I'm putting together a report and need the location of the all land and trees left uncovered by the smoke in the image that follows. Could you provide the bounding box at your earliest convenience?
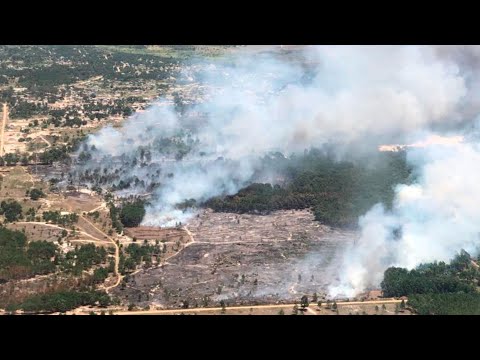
[0,46,474,315]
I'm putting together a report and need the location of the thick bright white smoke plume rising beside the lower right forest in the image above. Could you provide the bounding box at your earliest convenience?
[330,139,480,296]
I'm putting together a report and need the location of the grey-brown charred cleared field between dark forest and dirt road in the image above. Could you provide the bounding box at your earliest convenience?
[114,210,356,307]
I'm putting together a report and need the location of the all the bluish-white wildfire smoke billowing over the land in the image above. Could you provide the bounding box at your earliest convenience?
[73,46,480,295]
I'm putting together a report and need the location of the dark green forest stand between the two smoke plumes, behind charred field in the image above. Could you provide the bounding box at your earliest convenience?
[203,150,411,227]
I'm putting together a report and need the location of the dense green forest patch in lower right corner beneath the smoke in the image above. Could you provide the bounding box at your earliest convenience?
[381,251,480,315]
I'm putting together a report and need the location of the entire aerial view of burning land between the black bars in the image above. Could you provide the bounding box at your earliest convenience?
[0,45,480,315]
